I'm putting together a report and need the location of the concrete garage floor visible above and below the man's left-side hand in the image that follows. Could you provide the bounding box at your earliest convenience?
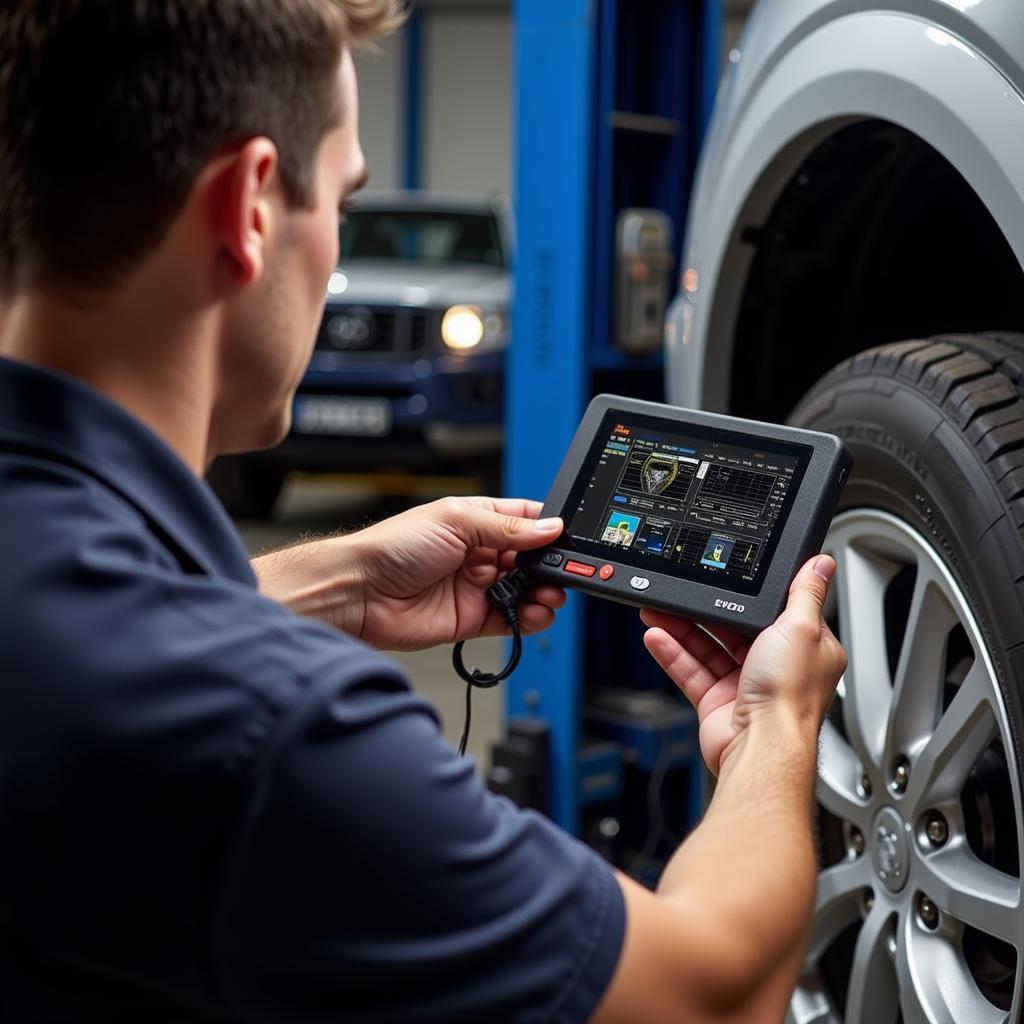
[238,474,504,769]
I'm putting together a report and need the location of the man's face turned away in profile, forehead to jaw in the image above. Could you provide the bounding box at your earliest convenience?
[216,49,366,451]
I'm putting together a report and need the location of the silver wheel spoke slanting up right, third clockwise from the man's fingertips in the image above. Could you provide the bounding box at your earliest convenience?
[905,662,998,812]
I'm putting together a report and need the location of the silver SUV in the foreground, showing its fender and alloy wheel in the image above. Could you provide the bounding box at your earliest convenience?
[668,0,1024,1024]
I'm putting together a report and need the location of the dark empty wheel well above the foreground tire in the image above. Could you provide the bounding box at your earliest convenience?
[729,121,1024,421]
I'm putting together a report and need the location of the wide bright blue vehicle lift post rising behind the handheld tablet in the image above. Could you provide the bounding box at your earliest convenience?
[505,0,722,847]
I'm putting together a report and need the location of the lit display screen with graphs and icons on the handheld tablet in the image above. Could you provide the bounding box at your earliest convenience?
[563,412,812,594]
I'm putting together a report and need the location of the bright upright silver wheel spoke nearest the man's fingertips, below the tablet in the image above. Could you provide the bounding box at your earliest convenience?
[836,544,896,767]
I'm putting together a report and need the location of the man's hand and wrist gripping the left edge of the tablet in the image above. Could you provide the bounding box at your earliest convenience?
[254,498,565,650]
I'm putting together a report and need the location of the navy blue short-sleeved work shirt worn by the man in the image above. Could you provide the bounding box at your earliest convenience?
[0,359,625,1024]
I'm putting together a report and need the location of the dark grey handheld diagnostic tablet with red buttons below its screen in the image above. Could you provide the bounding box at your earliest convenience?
[517,395,852,635]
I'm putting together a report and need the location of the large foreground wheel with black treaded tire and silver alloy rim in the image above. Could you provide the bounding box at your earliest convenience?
[788,335,1024,1024]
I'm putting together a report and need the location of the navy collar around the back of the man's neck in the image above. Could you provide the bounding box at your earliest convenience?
[0,356,256,586]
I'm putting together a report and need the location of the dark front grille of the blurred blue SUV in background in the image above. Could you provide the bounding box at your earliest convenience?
[316,306,440,358]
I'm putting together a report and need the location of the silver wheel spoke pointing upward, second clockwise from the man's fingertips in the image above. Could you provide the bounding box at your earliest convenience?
[885,564,957,766]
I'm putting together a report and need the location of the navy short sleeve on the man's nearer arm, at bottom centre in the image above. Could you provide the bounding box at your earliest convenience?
[216,658,625,1024]
